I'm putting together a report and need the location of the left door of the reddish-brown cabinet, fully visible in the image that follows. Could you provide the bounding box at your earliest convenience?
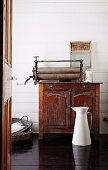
[43,91,70,129]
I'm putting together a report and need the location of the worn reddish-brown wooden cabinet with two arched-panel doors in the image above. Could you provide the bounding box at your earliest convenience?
[39,82,100,139]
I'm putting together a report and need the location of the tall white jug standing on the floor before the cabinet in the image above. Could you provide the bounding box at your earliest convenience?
[72,107,91,146]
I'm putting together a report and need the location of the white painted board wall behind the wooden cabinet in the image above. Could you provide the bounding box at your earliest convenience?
[12,0,108,133]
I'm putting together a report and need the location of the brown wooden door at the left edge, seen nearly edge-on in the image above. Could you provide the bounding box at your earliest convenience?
[0,0,12,170]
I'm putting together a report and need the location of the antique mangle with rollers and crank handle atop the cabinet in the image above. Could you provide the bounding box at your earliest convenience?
[25,56,83,84]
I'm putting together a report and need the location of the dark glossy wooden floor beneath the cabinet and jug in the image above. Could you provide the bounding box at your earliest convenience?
[11,134,108,170]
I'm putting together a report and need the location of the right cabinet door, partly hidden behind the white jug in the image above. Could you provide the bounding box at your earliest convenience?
[70,89,96,132]
